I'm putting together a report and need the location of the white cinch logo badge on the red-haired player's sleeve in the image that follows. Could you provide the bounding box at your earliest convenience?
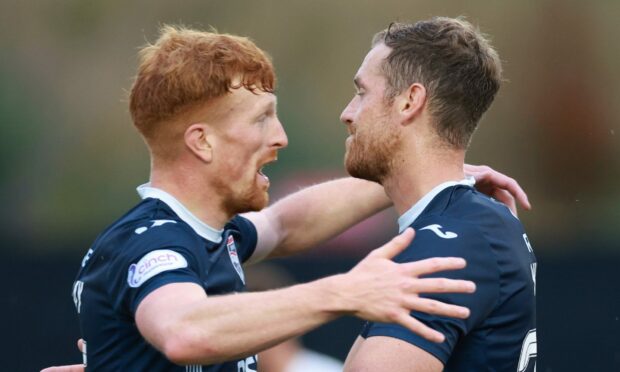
[127,249,187,288]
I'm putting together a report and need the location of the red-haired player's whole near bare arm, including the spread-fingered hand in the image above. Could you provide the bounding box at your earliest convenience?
[135,229,475,364]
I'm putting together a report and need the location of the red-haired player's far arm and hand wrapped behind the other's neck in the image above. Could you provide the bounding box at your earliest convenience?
[245,165,530,262]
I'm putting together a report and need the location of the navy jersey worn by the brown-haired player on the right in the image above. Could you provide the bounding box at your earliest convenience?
[361,181,537,372]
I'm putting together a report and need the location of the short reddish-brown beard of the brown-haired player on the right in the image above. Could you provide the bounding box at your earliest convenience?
[344,108,402,184]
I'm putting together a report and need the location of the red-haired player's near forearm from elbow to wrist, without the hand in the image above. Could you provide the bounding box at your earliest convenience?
[148,276,347,364]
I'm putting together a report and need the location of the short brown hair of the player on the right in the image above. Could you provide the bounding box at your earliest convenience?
[372,17,502,149]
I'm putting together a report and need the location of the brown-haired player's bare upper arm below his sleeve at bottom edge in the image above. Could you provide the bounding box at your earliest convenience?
[344,336,443,372]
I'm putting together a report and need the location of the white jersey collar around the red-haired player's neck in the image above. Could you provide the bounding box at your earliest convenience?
[136,183,224,243]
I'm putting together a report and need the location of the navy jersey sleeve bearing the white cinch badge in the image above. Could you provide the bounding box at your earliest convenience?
[109,224,206,316]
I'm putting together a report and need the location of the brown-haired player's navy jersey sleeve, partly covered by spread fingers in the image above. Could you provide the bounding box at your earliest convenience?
[361,218,499,365]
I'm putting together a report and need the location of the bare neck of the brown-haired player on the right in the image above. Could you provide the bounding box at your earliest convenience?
[383,147,465,215]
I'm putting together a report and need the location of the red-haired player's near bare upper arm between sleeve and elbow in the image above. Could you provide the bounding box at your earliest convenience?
[135,283,207,350]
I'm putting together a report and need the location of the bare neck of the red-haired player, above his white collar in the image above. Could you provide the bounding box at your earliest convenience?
[150,164,233,230]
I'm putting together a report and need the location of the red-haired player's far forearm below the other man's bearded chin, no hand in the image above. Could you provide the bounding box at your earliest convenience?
[265,178,392,257]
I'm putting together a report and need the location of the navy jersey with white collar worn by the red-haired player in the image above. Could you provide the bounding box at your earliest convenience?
[73,185,257,372]
